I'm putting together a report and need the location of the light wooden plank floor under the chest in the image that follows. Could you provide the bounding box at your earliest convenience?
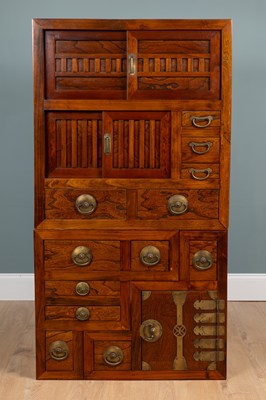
[0,301,266,400]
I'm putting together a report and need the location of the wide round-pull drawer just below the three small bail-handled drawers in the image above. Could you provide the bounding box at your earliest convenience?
[137,189,219,220]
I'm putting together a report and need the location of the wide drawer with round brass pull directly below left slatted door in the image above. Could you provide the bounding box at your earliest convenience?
[45,189,126,220]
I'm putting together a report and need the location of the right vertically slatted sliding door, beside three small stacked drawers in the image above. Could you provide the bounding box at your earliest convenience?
[104,112,170,178]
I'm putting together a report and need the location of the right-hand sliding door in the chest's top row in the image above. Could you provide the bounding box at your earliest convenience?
[128,30,220,99]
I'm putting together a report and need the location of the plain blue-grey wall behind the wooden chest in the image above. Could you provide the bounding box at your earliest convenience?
[0,0,266,273]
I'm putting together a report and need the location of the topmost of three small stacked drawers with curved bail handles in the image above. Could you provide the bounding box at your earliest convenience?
[182,111,221,129]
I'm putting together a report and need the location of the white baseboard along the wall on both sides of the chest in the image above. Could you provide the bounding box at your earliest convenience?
[0,274,266,301]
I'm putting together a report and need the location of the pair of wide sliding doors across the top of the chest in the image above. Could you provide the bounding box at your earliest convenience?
[44,29,221,100]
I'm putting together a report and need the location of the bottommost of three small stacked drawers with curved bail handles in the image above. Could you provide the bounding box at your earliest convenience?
[181,163,220,181]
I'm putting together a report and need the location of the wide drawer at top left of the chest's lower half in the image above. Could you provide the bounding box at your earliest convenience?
[44,240,120,272]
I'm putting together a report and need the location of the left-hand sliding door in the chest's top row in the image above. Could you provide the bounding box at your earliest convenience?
[45,31,127,99]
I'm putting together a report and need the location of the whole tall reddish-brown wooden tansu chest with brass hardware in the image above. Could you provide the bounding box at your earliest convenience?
[33,19,231,380]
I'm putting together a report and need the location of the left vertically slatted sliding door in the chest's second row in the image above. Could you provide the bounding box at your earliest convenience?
[46,112,102,177]
